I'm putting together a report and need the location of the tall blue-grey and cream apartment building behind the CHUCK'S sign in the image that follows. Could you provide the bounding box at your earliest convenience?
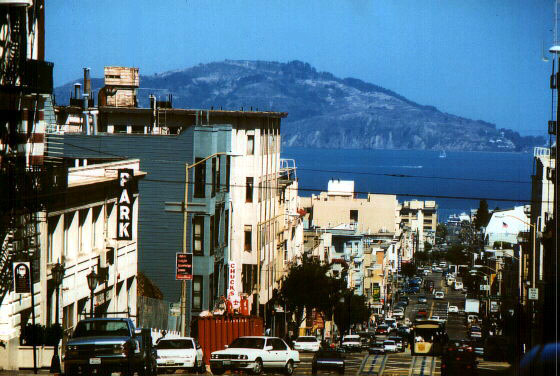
[56,67,303,326]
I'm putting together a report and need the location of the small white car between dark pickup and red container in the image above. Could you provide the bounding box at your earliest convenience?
[156,337,206,372]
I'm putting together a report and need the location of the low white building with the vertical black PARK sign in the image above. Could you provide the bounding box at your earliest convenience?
[0,160,145,369]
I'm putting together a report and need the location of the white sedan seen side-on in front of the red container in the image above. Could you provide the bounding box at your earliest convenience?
[210,336,299,375]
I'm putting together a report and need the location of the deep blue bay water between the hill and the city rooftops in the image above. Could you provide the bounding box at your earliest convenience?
[282,148,533,221]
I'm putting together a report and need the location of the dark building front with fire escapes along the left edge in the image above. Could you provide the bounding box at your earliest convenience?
[0,0,61,304]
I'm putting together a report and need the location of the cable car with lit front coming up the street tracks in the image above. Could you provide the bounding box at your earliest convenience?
[411,320,448,356]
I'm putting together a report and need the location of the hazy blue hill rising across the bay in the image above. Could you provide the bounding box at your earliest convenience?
[55,60,545,151]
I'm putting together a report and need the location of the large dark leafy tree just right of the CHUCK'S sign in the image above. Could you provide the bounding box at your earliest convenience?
[280,255,344,326]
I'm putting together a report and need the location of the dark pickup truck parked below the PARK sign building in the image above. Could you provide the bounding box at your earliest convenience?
[64,318,156,376]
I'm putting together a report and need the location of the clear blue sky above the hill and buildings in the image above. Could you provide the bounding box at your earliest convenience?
[46,0,554,135]
